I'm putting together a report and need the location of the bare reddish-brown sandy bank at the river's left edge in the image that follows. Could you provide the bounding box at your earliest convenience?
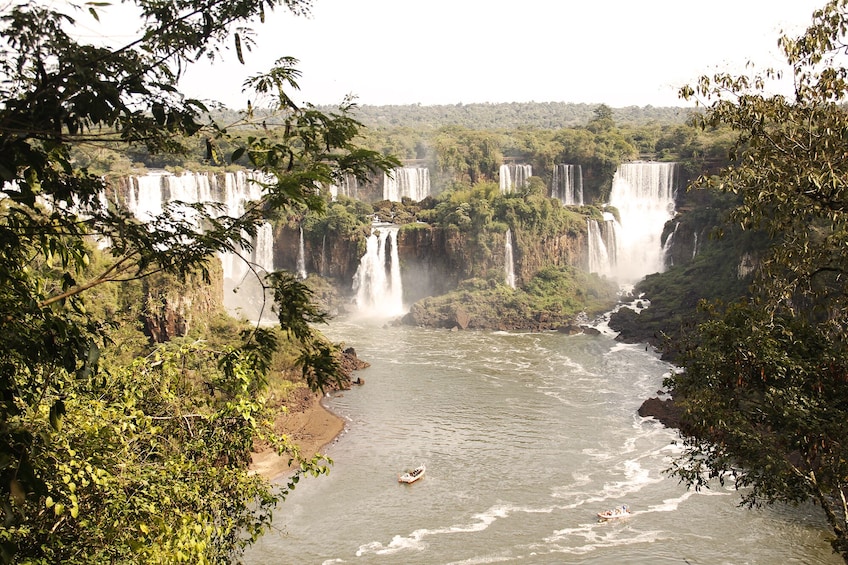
[250,389,345,481]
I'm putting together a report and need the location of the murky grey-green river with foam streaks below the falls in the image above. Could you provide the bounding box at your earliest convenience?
[246,312,842,565]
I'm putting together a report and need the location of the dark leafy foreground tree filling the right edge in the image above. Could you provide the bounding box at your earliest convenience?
[669,0,848,562]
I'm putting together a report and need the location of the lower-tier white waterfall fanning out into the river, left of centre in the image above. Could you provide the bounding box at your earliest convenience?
[353,224,404,316]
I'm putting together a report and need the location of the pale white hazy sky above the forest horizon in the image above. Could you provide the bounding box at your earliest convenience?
[117,0,825,108]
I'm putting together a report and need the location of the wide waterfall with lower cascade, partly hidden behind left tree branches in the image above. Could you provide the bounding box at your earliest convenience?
[127,167,274,317]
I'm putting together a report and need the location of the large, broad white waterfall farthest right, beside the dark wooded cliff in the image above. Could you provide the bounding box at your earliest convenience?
[609,162,675,283]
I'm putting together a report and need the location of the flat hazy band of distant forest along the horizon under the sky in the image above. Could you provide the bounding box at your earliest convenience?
[318,102,696,130]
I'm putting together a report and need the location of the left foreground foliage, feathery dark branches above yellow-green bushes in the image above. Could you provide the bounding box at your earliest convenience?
[0,0,398,563]
